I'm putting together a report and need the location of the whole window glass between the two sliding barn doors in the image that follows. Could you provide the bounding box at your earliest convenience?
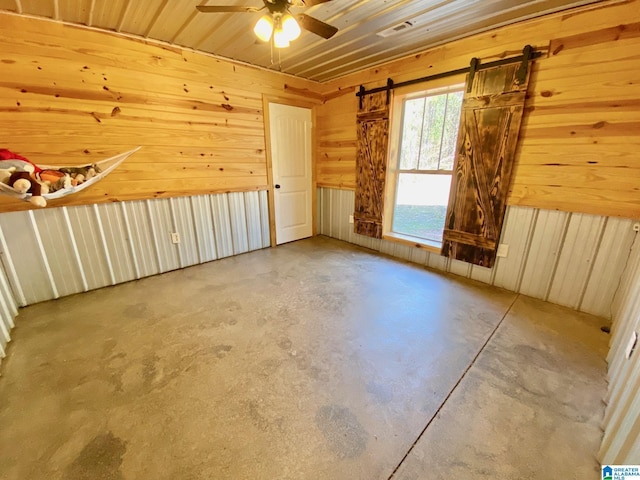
[389,87,463,246]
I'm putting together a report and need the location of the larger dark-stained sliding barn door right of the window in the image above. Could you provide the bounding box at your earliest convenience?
[442,64,530,267]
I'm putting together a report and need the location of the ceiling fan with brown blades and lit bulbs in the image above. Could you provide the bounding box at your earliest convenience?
[196,0,338,48]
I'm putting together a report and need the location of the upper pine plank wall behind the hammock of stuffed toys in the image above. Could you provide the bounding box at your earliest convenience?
[0,14,317,212]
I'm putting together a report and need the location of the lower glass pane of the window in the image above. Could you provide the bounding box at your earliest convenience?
[392,173,451,243]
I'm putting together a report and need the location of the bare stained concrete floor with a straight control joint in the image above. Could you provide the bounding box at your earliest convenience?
[0,237,608,480]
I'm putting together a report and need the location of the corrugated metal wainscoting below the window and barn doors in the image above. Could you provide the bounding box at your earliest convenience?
[318,188,635,318]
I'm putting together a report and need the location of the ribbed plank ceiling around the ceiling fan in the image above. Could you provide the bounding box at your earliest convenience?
[0,0,598,82]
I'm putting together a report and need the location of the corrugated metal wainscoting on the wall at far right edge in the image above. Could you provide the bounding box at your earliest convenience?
[599,234,640,465]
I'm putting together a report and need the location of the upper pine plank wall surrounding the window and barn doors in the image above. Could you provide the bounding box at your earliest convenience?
[317,0,640,218]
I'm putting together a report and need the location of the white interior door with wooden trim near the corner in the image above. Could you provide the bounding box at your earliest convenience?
[269,103,313,245]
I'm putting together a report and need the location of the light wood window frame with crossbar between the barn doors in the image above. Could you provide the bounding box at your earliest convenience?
[382,78,465,253]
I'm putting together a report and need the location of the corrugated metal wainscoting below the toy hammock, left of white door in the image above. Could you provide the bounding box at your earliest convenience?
[0,191,270,306]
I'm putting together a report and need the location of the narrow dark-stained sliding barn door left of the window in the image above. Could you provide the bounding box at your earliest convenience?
[354,92,390,238]
